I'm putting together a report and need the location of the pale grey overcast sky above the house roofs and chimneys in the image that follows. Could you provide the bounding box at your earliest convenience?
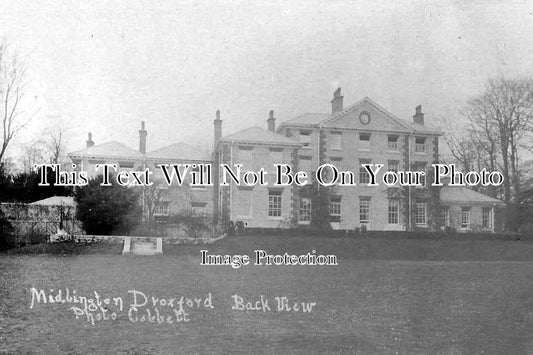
[0,0,533,161]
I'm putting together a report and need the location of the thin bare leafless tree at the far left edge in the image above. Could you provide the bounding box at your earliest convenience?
[0,41,29,168]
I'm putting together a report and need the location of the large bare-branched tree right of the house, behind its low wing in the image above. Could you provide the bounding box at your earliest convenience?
[447,78,533,204]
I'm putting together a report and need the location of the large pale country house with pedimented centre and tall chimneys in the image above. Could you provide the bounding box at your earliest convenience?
[70,88,502,231]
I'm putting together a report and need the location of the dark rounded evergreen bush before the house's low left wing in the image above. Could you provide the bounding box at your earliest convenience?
[75,176,142,235]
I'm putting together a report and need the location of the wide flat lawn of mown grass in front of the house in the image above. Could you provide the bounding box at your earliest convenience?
[0,236,533,354]
